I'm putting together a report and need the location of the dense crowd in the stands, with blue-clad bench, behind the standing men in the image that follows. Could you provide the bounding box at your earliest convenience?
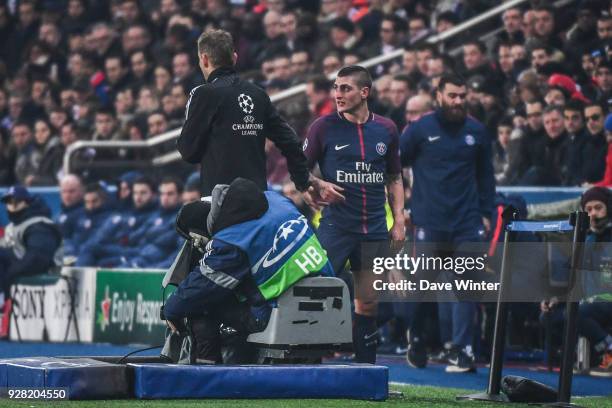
[0,0,612,374]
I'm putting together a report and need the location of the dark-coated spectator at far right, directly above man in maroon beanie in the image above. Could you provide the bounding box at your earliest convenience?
[581,104,608,184]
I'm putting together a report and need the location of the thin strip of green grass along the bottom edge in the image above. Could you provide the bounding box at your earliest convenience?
[0,382,612,408]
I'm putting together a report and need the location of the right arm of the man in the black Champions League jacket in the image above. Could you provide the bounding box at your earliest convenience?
[266,99,309,191]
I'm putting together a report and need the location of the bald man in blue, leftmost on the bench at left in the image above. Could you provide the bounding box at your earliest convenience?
[55,174,84,247]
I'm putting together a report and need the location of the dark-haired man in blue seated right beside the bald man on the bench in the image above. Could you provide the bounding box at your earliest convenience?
[64,183,117,258]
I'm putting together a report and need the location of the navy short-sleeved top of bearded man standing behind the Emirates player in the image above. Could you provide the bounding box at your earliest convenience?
[400,111,495,231]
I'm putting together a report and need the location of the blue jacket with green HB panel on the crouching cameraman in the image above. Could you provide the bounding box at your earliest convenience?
[164,188,333,319]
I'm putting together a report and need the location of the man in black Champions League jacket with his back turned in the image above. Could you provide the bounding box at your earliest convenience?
[177,30,309,196]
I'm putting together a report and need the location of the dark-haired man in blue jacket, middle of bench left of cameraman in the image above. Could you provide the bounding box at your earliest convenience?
[77,176,158,266]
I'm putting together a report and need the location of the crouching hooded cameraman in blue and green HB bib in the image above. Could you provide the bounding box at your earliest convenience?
[163,178,333,364]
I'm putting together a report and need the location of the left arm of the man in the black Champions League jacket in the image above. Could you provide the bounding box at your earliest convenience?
[176,85,219,164]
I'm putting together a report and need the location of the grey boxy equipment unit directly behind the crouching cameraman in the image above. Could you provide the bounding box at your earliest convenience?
[248,277,352,363]
